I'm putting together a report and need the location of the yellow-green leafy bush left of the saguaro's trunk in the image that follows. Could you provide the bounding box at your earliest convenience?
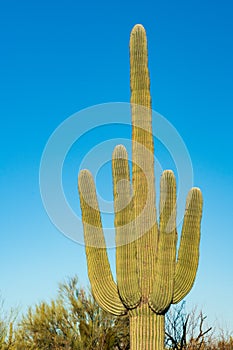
[11,277,129,350]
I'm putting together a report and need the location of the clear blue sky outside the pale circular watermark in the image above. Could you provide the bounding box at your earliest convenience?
[0,0,233,330]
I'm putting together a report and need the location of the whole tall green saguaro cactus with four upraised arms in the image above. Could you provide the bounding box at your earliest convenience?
[78,25,202,350]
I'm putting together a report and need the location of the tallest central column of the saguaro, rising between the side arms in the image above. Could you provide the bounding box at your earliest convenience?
[130,25,158,302]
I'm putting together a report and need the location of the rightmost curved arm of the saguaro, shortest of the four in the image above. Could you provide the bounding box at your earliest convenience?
[172,188,203,304]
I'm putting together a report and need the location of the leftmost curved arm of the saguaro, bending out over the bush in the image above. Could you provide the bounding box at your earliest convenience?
[78,170,127,315]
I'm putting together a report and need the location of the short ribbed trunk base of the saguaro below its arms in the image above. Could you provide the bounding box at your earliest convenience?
[130,307,164,350]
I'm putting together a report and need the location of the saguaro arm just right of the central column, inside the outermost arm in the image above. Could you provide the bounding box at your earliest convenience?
[149,170,177,313]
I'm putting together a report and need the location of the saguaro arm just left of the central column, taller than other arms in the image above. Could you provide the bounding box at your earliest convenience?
[112,145,141,309]
